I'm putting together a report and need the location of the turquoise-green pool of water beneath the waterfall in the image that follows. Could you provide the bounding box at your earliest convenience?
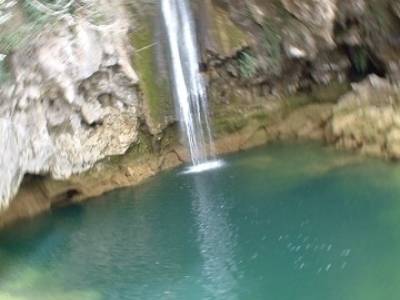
[0,144,400,300]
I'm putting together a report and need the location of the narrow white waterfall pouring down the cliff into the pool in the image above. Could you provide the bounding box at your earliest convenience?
[161,0,222,170]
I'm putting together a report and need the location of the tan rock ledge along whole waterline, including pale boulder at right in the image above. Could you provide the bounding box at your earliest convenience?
[0,76,400,227]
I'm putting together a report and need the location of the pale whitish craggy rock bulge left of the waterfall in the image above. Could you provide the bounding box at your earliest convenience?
[0,3,140,208]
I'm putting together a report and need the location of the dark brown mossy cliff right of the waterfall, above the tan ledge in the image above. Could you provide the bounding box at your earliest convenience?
[198,0,400,102]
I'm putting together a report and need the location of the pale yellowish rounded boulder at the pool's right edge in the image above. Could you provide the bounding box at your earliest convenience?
[326,76,400,159]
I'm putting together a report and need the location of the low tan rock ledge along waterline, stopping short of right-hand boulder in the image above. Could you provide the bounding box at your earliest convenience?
[0,99,384,228]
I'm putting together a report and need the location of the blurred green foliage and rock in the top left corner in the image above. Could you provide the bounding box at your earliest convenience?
[0,0,126,84]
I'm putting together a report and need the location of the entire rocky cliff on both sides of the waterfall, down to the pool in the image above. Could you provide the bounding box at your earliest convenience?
[0,0,400,227]
